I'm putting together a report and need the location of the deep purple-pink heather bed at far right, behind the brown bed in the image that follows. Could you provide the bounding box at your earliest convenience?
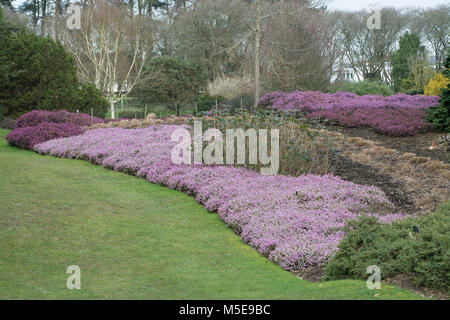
[259,91,439,136]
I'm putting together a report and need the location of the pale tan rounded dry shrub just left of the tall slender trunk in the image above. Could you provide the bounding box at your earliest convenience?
[208,76,254,99]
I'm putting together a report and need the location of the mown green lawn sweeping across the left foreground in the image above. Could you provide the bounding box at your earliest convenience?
[0,130,421,299]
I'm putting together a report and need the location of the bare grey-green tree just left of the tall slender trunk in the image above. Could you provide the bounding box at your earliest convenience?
[171,0,248,81]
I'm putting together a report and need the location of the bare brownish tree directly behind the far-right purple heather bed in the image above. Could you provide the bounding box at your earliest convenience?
[261,3,341,91]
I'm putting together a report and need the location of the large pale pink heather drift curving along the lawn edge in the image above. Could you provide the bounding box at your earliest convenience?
[34,125,405,270]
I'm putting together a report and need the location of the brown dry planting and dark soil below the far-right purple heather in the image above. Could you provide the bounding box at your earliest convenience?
[321,127,450,214]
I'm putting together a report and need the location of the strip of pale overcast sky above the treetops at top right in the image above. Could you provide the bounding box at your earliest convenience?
[327,0,449,11]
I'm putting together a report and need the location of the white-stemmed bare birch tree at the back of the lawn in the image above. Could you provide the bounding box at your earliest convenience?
[61,0,152,118]
